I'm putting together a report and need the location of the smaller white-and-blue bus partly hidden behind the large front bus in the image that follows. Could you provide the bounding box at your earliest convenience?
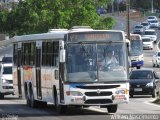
[126,34,144,69]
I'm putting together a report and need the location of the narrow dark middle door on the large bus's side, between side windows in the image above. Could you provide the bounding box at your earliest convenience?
[35,41,42,99]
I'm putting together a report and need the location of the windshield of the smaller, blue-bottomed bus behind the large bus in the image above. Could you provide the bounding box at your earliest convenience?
[131,40,143,56]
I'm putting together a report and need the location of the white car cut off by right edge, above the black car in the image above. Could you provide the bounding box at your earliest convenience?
[152,51,160,67]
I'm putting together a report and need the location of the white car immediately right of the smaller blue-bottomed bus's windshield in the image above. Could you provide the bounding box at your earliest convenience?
[142,37,153,50]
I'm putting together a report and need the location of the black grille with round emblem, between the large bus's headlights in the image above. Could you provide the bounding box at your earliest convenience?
[85,92,112,96]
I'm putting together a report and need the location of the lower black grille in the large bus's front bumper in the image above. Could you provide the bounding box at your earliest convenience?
[84,99,112,104]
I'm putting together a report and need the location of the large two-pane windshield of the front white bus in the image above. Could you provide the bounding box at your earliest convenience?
[66,43,127,82]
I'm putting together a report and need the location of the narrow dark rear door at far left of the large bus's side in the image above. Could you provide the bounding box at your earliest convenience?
[17,43,22,98]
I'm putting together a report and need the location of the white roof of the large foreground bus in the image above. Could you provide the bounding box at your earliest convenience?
[11,28,125,42]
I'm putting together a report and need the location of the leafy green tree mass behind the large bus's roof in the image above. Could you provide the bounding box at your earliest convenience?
[0,0,113,36]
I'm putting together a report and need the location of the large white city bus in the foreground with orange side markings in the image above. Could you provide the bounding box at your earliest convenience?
[13,28,129,113]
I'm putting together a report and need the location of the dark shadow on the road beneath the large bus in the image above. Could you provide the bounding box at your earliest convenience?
[0,103,111,118]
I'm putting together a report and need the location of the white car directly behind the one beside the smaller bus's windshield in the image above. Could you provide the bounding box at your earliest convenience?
[142,29,157,43]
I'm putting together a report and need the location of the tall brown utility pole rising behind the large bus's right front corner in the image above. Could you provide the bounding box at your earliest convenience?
[126,0,130,40]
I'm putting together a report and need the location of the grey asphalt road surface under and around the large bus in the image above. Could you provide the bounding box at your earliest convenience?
[0,19,160,120]
